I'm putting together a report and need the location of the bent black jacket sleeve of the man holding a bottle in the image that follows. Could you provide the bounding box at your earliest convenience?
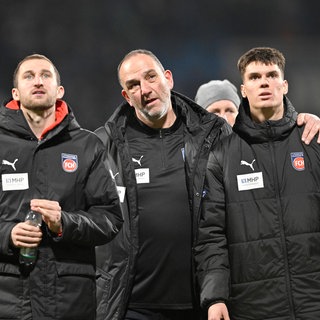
[55,145,123,246]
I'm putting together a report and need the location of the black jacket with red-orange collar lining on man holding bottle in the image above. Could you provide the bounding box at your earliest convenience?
[0,101,122,320]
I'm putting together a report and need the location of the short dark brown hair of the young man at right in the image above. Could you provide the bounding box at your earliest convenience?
[237,47,286,79]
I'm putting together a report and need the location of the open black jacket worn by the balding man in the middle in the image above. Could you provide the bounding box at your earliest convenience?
[96,92,230,320]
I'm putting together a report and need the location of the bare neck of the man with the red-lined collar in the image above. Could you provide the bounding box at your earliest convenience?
[21,105,56,139]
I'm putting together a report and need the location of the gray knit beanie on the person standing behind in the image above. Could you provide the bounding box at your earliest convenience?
[195,80,240,109]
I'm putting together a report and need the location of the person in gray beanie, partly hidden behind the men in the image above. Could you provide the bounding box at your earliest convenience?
[195,79,240,126]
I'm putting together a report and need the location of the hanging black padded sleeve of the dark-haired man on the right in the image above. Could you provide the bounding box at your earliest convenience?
[194,152,229,309]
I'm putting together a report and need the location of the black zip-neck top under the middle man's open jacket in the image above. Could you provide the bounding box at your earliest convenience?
[126,112,192,309]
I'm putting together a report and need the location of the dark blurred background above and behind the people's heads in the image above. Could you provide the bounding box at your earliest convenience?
[0,0,320,130]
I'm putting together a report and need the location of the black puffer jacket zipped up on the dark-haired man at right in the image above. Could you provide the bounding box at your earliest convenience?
[195,98,320,320]
